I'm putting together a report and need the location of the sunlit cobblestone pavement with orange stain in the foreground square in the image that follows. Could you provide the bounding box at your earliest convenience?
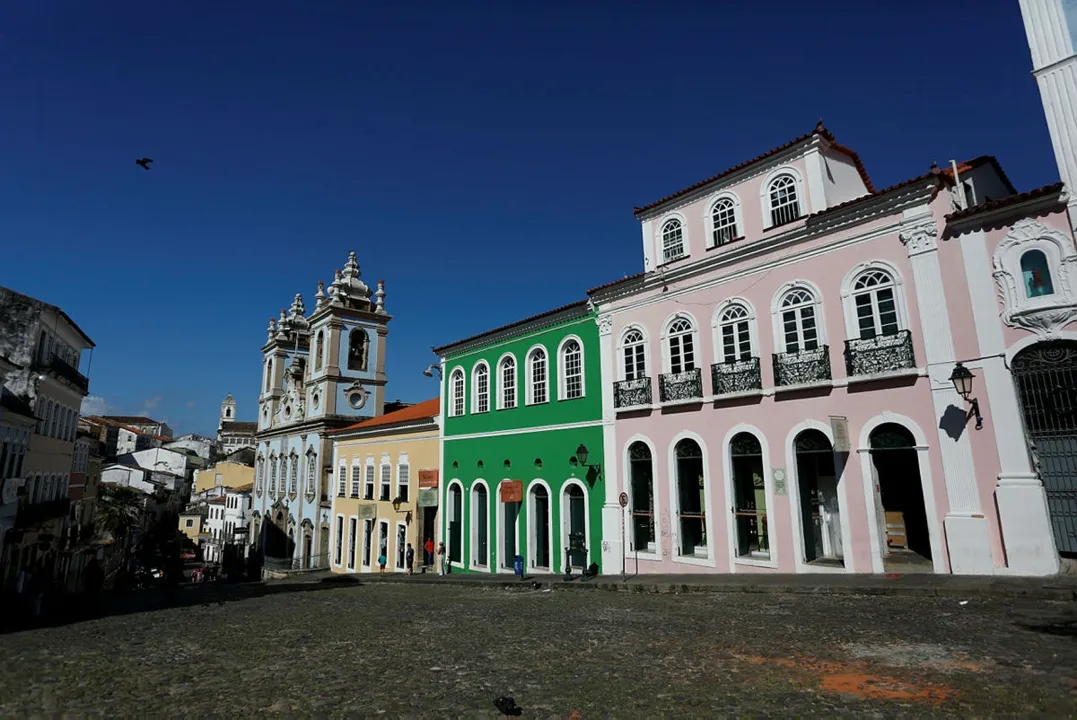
[0,580,1077,718]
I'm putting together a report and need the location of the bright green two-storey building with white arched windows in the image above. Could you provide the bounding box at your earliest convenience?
[434,301,605,575]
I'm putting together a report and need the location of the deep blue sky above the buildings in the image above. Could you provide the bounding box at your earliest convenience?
[0,0,1058,433]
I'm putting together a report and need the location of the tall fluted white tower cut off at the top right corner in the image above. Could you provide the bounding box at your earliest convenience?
[1019,0,1077,230]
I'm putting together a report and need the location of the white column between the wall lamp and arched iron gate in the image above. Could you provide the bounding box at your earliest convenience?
[961,230,1059,576]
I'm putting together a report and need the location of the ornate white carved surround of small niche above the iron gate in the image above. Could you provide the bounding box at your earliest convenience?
[993,217,1077,339]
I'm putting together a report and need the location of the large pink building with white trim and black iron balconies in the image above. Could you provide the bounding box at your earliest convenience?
[590,120,1077,575]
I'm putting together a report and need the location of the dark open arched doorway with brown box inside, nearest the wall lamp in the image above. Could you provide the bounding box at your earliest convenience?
[868,423,933,570]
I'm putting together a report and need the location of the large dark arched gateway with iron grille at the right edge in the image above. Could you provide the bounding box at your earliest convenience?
[1010,340,1077,556]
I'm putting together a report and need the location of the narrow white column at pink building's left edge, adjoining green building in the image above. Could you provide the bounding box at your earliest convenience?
[598,314,625,575]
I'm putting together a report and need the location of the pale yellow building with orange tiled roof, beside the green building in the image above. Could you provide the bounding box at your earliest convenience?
[330,398,440,573]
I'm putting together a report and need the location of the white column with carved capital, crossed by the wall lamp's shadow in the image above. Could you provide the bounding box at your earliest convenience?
[900,213,994,575]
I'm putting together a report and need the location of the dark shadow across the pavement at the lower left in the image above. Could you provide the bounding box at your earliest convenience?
[0,576,360,635]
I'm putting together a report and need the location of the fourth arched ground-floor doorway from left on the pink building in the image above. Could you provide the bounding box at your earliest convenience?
[794,429,844,566]
